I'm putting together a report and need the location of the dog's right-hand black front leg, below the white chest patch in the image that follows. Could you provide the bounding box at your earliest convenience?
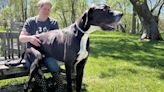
[76,59,86,92]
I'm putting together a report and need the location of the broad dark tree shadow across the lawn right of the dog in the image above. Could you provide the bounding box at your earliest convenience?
[90,37,164,79]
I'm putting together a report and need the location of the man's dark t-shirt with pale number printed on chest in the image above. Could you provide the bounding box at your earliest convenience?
[22,16,59,47]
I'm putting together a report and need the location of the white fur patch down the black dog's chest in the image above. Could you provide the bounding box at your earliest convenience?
[76,34,89,61]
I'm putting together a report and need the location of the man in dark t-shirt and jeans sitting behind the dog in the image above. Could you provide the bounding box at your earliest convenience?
[19,0,63,92]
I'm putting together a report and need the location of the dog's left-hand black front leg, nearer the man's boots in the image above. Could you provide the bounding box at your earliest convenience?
[65,61,72,92]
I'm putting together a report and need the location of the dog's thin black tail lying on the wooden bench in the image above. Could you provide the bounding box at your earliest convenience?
[5,51,26,67]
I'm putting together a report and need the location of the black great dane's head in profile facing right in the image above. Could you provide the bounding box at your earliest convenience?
[82,4,123,30]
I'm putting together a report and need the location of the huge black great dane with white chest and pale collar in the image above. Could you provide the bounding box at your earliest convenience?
[6,4,123,92]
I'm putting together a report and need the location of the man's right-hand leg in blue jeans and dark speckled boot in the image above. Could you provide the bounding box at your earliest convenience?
[44,57,64,92]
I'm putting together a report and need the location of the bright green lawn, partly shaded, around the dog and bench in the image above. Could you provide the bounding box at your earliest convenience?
[0,32,164,92]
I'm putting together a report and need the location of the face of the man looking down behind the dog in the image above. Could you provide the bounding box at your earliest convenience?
[39,4,51,17]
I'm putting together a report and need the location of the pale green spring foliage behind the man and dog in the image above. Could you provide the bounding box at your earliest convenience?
[0,0,162,32]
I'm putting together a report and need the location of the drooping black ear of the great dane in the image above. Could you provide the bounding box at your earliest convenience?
[82,7,93,28]
